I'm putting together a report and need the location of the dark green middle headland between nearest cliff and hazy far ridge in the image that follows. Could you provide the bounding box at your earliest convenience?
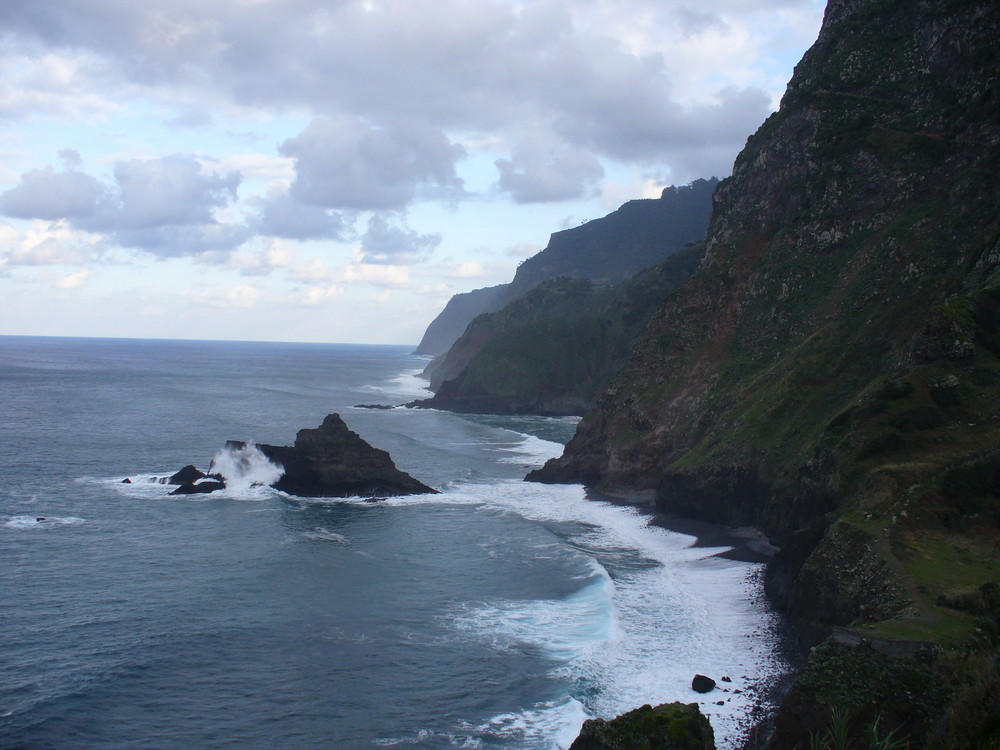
[417,243,704,416]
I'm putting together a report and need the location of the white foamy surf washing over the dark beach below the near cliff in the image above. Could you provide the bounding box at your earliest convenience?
[398,481,788,750]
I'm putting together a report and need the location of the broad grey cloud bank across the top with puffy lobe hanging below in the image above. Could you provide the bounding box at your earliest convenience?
[0,0,810,179]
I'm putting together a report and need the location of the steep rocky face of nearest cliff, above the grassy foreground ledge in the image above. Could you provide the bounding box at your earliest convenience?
[532,0,1000,535]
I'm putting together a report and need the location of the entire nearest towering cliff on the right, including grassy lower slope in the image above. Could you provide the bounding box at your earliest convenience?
[529,0,1000,748]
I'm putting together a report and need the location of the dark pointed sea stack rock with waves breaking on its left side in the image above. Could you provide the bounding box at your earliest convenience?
[257,414,437,497]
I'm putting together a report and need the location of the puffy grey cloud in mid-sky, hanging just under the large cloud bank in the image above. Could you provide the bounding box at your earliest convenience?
[278,117,464,210]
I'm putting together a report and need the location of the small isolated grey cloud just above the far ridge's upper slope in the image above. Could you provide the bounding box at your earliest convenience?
[496,140,604,203]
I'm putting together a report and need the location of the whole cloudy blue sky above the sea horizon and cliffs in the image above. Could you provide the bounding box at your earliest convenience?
[0,0,824,344]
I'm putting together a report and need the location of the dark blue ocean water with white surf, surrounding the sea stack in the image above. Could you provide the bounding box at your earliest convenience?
[0,337,783,749]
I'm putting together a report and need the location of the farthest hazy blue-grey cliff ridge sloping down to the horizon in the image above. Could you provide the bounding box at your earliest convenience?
[417,177,718,382]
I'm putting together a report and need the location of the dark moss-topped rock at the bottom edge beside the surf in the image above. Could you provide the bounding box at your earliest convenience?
[570,703,715,750]
